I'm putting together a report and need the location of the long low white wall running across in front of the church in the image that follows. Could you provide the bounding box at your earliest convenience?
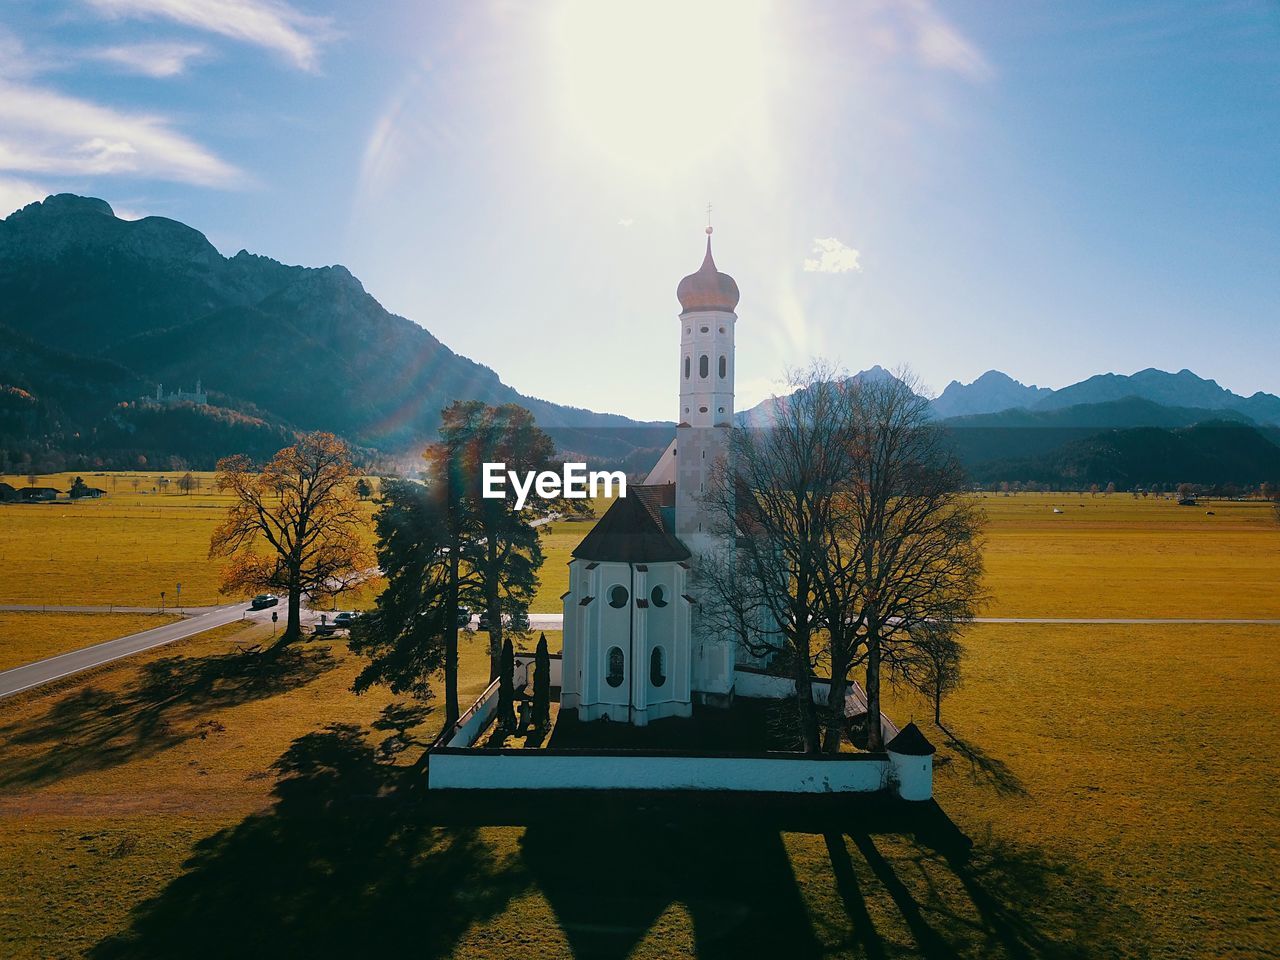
[429,750,890,794]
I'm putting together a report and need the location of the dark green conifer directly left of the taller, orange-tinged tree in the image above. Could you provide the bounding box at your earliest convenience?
[348,480,457,706]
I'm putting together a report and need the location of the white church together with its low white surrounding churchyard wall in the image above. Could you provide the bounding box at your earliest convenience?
[430,227,933,800]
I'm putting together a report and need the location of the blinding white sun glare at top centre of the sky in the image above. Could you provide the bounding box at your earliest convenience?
[550,0,778,174]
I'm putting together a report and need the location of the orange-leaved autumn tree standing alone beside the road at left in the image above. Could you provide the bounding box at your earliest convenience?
[209,433,372,645]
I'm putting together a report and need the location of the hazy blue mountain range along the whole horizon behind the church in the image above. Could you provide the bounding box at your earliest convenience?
[0,195,1280,483]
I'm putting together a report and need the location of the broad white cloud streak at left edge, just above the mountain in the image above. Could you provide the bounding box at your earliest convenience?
[0,79,242,187]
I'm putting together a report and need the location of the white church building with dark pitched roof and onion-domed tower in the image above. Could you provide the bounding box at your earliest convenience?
[561,227,746,726]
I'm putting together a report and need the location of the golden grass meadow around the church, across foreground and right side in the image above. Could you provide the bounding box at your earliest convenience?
[0,477,1280,957]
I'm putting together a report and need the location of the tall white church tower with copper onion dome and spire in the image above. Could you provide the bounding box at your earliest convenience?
[675,227,739,556]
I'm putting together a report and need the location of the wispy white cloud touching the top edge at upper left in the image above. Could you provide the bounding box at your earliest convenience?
[87,0,332,70]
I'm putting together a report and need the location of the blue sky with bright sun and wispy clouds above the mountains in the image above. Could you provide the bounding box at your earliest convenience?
[0,0,1280,420]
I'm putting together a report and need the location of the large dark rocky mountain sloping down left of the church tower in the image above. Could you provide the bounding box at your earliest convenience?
[0,195,673,468]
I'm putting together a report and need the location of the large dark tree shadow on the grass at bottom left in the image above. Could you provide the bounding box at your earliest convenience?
[90,724,529,960]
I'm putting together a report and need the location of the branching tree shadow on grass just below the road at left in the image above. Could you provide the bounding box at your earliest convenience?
[0,648,337,787]
